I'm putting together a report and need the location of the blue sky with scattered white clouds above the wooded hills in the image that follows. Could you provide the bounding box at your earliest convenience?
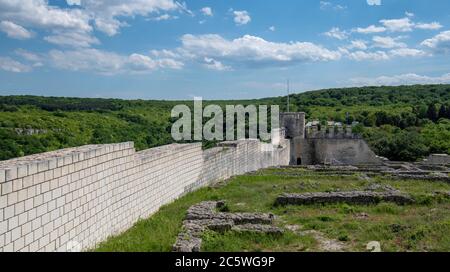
[0,0,450,100]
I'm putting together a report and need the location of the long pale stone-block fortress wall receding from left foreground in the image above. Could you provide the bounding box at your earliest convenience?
[0,140,290,252]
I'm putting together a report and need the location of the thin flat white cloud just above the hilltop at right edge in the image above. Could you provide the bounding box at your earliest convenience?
[349,73,450,86]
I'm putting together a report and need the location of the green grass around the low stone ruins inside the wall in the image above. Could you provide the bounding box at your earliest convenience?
[96,169,450,252]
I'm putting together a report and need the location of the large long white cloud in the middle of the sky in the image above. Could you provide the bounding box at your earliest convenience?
[179,34,341,69]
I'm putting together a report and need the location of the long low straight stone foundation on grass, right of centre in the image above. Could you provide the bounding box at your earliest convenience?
[276,191,414,206]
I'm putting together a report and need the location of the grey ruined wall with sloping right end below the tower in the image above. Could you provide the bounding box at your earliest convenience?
[296,139,382,165]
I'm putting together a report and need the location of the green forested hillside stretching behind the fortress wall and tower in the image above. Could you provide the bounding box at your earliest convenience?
[0,85,450,161]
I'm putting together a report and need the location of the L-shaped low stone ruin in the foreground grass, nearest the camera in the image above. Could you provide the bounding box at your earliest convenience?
[173,201,283,252]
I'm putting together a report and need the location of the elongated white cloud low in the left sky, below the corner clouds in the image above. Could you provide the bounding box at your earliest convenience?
[49,48,184,75]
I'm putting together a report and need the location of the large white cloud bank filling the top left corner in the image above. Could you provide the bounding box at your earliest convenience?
[0,0,184,39]
